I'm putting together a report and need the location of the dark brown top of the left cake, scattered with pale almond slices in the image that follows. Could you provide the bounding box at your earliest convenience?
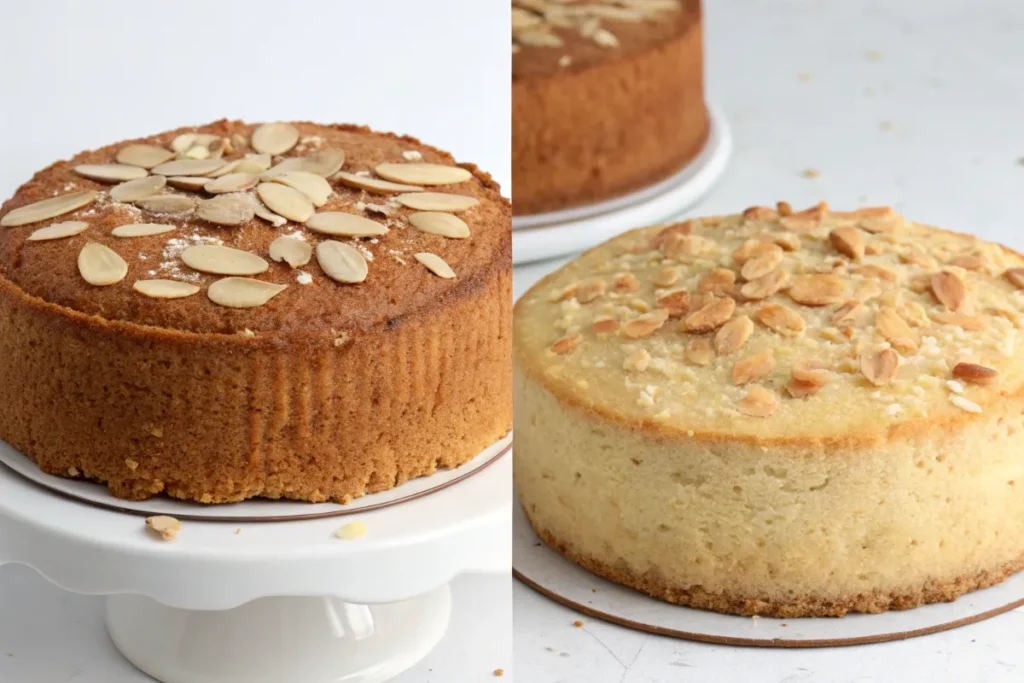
[0,120,511,339]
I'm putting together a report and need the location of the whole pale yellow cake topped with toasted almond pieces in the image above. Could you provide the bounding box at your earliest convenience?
[513,203,1024,617]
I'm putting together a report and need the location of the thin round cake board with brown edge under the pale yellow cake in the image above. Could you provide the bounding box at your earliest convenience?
[512,495,1024,647]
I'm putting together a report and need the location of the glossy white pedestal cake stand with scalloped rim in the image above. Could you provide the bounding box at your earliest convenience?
[0,440,511,683]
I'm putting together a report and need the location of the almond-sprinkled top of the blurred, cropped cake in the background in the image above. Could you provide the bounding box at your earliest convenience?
[512,0,700,81]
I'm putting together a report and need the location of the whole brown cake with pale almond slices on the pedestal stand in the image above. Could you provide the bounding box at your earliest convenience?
[0,121,512,503]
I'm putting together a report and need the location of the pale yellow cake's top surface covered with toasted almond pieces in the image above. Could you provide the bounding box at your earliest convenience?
[515,203,1024,439]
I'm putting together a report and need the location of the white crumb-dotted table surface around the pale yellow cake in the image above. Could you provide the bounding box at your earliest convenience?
[514,0,1024,683]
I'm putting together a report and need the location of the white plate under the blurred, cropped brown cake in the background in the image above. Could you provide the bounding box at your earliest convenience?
[512,102,732,263]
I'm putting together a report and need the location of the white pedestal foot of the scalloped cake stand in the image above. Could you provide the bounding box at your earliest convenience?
[106,586,452,683]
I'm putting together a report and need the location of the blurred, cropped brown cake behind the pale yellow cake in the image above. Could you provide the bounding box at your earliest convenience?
[512,0,709,215]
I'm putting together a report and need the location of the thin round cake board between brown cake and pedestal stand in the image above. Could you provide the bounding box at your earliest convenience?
[0,434,512,521]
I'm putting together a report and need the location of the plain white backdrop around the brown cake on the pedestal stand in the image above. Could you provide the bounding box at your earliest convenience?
[0,0,511,683]
